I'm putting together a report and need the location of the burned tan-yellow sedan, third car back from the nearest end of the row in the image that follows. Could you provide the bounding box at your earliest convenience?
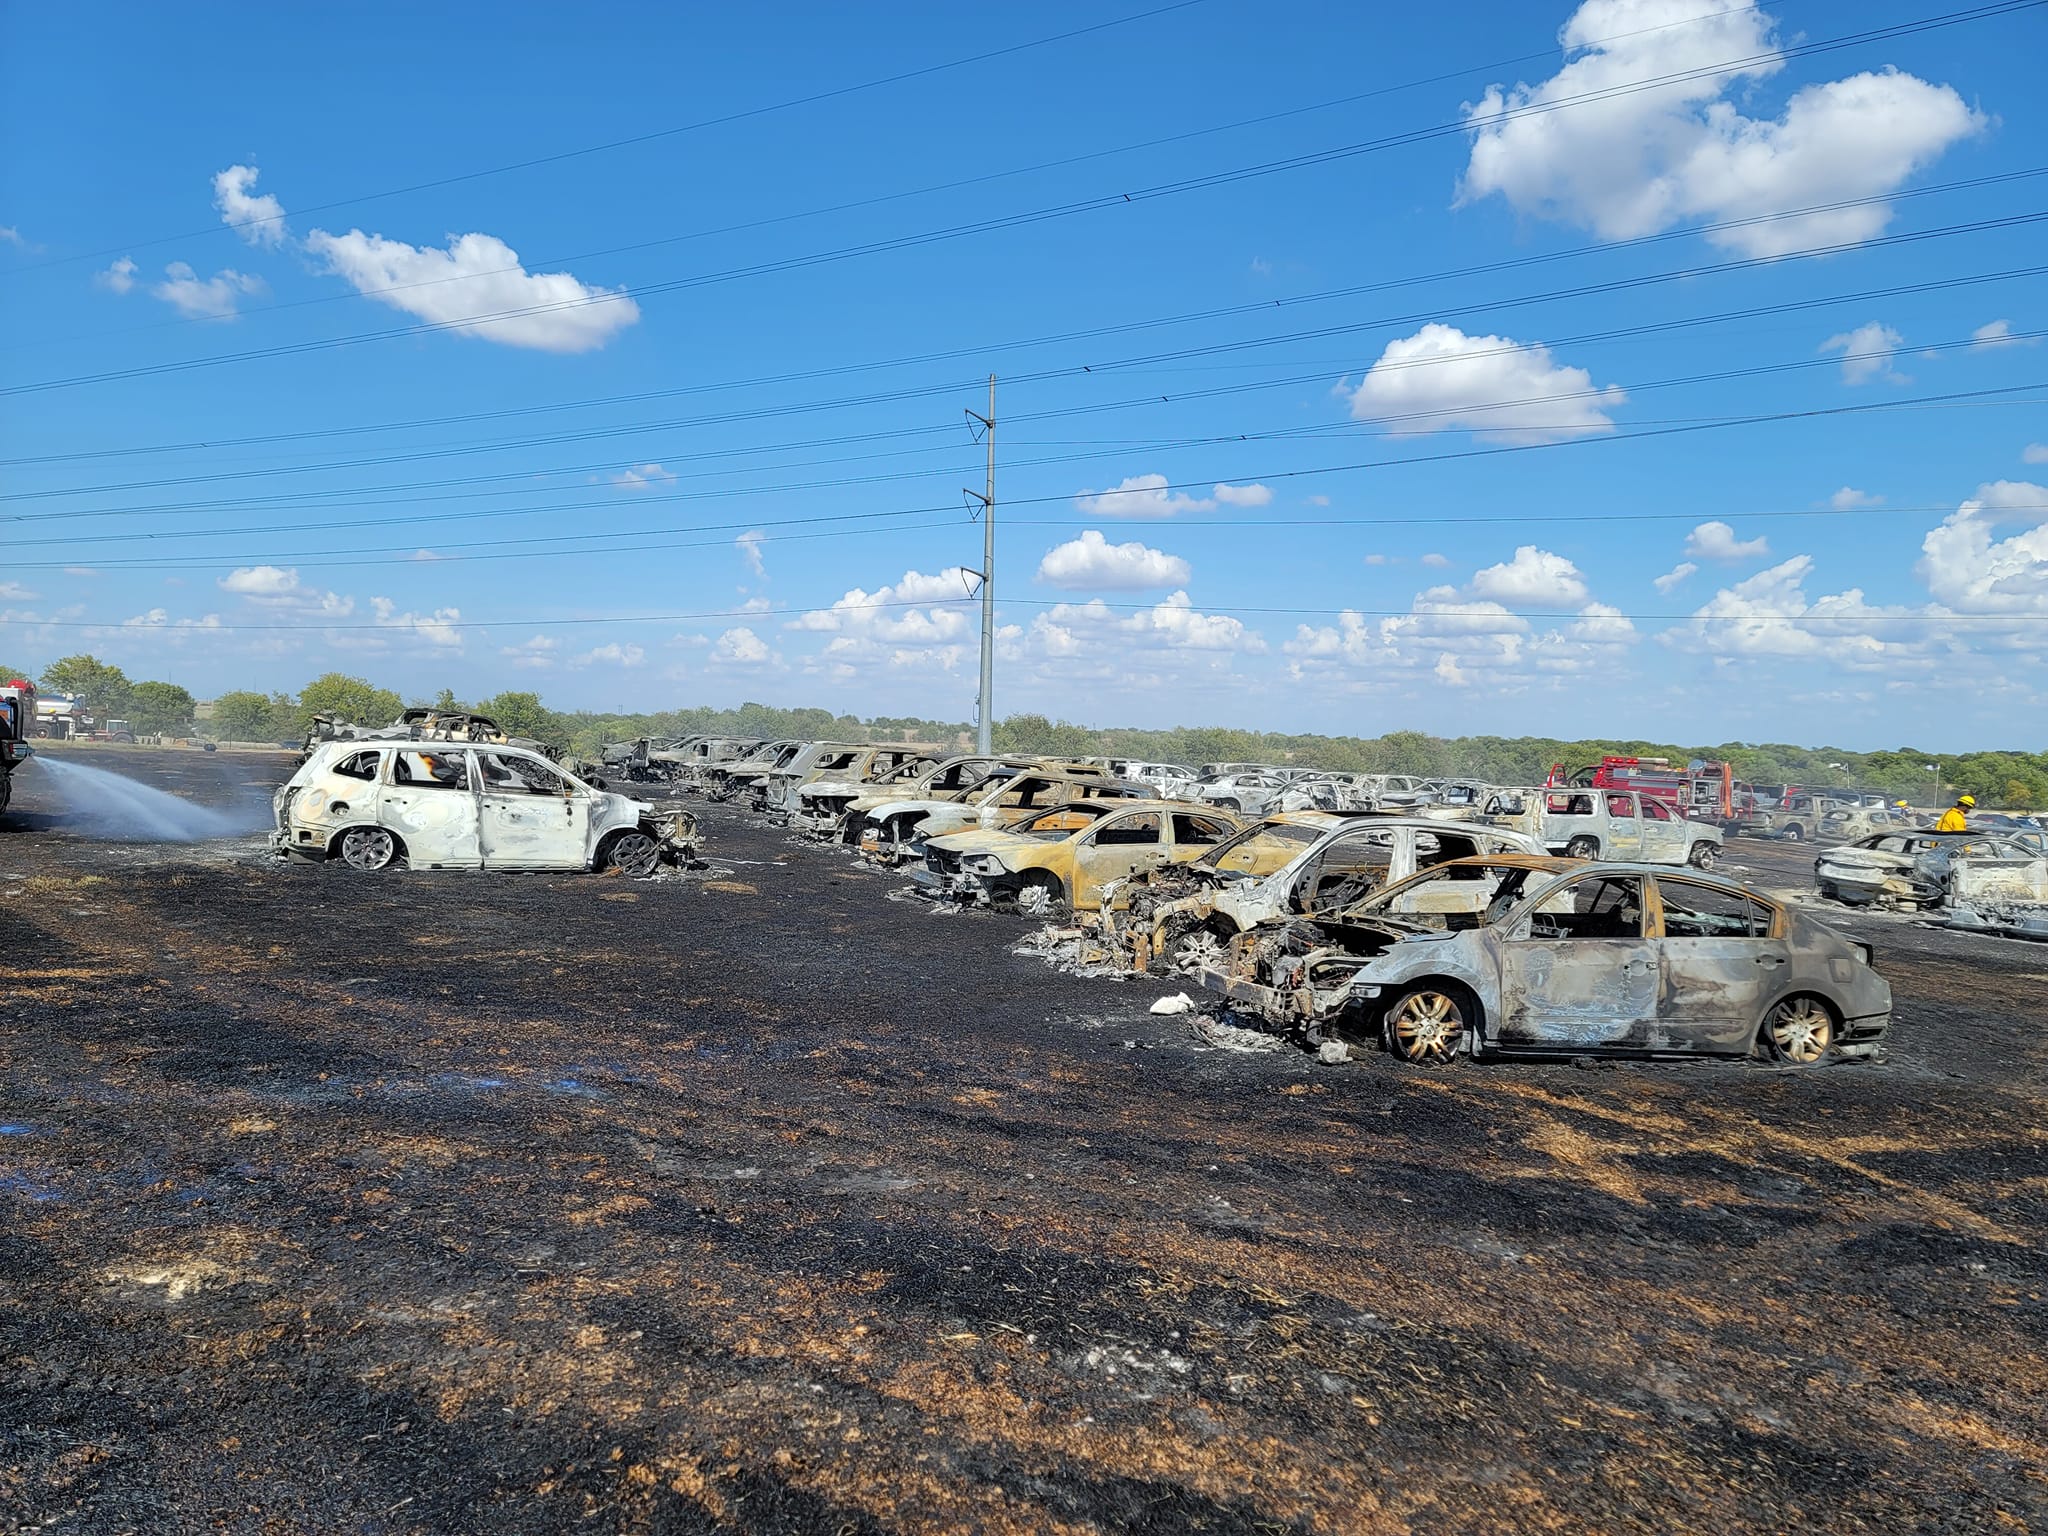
[915,801,1243,913]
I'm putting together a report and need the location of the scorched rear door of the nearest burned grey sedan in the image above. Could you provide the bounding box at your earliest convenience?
[1657,877,1792,1057]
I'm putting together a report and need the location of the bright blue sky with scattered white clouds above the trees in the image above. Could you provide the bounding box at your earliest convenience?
[0,0,2048,750]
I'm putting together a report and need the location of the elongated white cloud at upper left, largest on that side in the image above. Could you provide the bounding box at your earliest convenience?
[305,229,639,352]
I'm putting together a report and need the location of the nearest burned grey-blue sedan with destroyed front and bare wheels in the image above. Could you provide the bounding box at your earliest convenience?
[1200,856,1892,1067]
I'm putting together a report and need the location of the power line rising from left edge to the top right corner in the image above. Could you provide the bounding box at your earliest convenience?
[0,0,2048,395]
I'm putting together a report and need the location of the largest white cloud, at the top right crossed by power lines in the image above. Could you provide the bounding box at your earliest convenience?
[1460,0,1985,256]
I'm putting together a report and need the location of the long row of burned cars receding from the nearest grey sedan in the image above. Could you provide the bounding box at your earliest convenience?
[655,743,1890,1067]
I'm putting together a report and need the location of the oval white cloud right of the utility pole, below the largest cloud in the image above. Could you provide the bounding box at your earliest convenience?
[1352,322,1628,442]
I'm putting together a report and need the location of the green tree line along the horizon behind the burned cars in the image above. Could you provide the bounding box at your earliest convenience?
[0,655,2048,811]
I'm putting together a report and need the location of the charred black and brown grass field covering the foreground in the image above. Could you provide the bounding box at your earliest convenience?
[0,752,2048,1536]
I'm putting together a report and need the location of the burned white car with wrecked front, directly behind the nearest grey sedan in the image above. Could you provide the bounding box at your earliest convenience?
[1100,811,1542,975]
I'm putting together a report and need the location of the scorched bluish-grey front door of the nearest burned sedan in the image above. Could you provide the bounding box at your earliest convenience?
[1493,874,1659,1051]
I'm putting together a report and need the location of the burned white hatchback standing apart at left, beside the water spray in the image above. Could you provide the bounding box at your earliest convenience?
[270,741,696,874]
